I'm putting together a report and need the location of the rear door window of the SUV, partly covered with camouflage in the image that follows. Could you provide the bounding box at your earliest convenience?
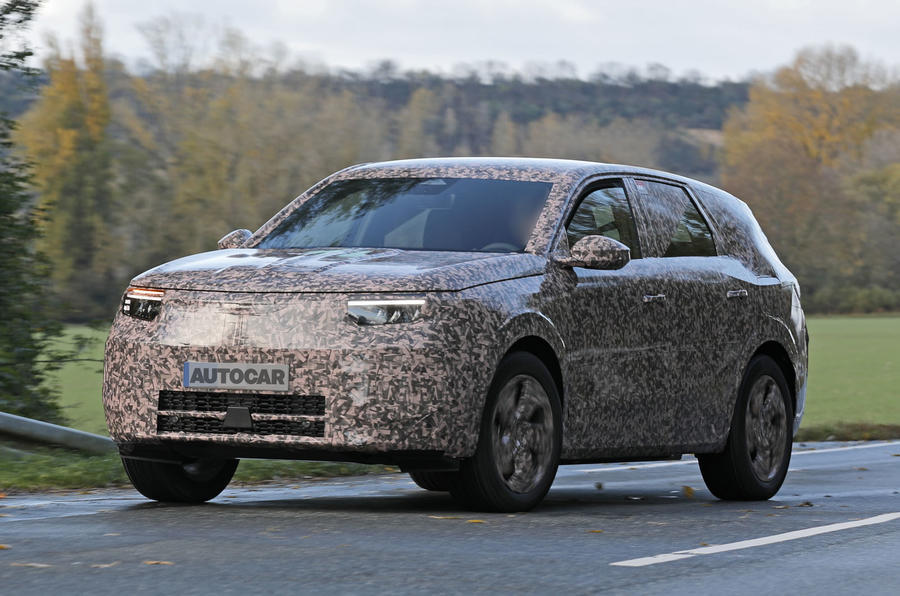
[634,180,716,257]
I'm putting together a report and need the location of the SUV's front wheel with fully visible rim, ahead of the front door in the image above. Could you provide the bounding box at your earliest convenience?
[450,352,562,512]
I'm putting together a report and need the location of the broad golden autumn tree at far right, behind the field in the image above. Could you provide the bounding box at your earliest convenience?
[722,46,900,309]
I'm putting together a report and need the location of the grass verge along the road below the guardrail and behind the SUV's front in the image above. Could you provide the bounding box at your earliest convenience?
[0,446,386,493]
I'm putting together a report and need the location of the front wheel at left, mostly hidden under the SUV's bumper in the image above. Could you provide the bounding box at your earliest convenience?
[122,457,238,503]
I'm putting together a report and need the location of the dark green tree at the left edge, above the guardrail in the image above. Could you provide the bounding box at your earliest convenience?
[0,0,62,421]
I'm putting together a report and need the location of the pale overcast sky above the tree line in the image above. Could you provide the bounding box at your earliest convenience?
[24,0,900,79]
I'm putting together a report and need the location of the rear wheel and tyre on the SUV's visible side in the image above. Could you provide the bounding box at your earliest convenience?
[697,356,794,501]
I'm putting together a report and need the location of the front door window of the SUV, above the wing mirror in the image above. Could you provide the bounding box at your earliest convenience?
[566,182,641,258]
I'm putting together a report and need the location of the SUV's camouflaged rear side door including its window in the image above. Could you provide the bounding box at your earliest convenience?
[631,177,748,446]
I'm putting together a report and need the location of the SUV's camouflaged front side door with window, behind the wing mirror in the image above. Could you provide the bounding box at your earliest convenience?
[542,180,676,459]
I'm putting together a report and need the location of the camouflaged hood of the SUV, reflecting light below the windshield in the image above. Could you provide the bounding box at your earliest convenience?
[132,248,546,292]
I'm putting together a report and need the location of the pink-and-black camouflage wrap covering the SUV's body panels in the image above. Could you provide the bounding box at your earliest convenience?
[103,158,806,461]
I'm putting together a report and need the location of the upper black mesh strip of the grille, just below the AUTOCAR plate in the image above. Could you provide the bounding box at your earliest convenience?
[159,391,325,416]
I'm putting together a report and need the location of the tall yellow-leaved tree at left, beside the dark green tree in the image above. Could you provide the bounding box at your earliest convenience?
[17,4,124,320]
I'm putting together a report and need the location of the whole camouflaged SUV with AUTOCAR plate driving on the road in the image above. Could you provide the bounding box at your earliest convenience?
[103,158,808,512]
